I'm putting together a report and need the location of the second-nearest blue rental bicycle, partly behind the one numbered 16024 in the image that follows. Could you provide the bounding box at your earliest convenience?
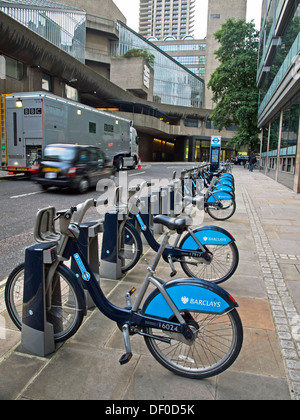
[119,181,239,284]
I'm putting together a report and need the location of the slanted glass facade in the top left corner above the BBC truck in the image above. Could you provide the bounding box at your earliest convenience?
[0,0,86,63]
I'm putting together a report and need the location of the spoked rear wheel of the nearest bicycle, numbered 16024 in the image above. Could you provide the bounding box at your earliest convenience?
[144,309,243,379]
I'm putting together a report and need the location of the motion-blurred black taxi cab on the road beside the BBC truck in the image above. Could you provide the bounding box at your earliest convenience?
[33,144,113,193]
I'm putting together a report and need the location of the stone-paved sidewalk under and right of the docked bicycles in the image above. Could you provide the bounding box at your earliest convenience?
[0,167,300,398]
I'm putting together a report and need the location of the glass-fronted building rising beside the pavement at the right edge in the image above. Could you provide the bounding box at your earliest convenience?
[258,0,300,189]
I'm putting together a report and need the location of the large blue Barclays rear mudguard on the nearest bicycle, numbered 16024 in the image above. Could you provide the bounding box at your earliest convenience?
[142,278,238,320]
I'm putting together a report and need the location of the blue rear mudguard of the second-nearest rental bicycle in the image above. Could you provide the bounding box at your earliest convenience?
[179,226,235,251]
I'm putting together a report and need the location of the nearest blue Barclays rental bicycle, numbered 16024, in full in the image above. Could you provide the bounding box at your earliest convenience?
[5,199,243,379]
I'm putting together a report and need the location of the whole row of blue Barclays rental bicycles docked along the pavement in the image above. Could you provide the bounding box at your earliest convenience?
[5,165,243,379]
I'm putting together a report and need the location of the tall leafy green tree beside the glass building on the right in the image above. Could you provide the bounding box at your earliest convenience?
[208,19,259,150]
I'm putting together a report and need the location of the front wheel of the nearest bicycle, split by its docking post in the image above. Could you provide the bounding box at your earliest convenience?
[5,263,84,343]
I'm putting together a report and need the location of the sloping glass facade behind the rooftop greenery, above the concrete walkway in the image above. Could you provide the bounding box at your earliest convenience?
[110,22,204,108]
